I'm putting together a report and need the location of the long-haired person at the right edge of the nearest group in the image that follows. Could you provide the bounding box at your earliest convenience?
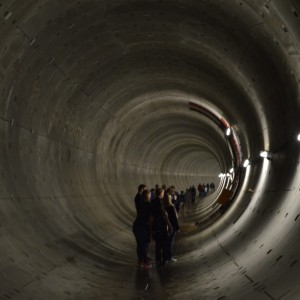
[166,195,179,262]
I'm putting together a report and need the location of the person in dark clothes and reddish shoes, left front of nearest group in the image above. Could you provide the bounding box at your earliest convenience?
[132,190,152,269]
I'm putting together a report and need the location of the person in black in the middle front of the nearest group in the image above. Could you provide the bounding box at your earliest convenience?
[152,188,173,266]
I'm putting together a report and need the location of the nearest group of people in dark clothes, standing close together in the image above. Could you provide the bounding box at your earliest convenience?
[132,184,179,269]
